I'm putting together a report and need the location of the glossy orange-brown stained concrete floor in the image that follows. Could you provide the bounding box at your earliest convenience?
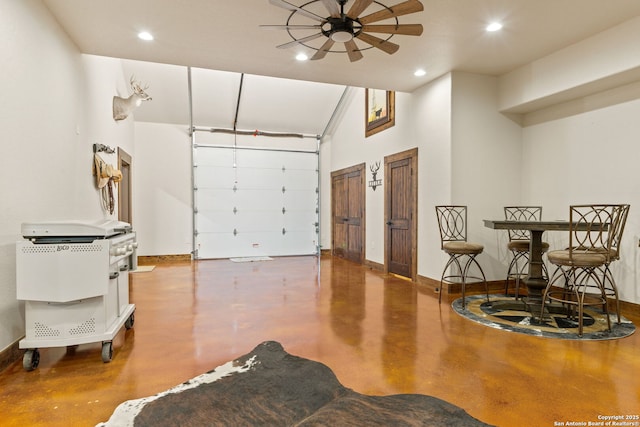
[0,257,640,427]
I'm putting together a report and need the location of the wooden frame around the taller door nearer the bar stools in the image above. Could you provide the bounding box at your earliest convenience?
[384,147,418,282]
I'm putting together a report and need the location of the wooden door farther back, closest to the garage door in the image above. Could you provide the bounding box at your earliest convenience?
[331,164,365,263]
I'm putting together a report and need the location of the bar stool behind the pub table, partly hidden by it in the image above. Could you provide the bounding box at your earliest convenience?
[504,206,549,299]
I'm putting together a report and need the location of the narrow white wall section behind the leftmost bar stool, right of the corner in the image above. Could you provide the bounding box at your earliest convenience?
[451,72,524,280]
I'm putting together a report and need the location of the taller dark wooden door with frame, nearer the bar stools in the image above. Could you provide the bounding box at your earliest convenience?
[384,148,418,280]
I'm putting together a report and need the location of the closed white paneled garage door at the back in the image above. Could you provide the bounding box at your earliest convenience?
[194,146,319,259]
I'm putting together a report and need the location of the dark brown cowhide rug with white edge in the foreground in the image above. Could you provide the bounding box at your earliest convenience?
[99,341,488,427]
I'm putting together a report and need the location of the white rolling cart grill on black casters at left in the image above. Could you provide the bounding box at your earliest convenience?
[16,220,137,371]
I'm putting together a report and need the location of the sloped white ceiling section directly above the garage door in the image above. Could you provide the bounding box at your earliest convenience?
[117,60,348,135]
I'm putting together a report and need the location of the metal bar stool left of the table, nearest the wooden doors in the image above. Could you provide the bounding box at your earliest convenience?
[436,205,489,309]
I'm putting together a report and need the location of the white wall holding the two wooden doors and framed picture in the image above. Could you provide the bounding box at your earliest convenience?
[322,75,451,277]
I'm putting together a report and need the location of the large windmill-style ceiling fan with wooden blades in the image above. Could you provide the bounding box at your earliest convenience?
[261,0,424,62]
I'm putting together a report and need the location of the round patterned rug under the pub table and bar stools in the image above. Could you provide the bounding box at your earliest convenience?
[451,295,636,340]
